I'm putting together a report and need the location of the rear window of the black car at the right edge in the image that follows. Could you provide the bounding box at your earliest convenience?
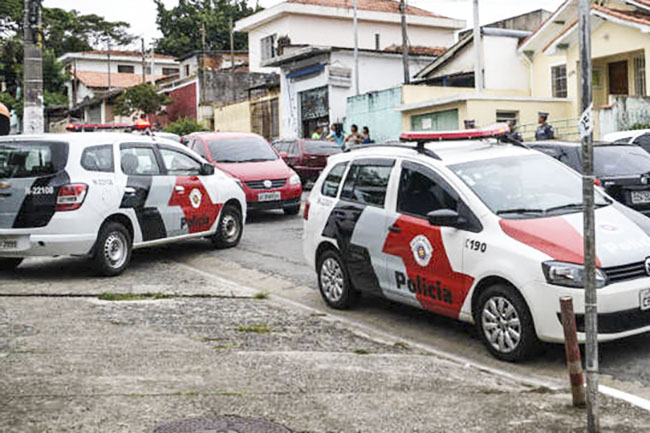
[594,146,650,177]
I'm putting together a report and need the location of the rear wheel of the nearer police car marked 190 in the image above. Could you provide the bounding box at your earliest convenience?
[317,250,360,310]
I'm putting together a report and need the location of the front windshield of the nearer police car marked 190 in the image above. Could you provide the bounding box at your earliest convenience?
[450,155,610,218]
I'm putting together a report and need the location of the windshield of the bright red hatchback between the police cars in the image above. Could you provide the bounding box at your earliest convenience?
[208,137,278,163]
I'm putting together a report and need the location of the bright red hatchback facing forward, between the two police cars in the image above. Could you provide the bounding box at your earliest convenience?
[183,132,302,215]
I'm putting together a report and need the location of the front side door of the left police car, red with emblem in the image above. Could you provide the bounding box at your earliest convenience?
[159,146,221,236]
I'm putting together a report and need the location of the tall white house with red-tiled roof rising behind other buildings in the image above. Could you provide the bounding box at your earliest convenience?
[235,0,465,72]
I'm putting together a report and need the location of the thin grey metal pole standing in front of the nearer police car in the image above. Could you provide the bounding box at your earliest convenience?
[578,0,600,433]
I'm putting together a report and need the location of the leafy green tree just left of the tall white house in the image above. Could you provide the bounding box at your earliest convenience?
[154,0,261,56]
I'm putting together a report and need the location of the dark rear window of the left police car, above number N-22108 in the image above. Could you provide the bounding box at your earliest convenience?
[0,141,68,179]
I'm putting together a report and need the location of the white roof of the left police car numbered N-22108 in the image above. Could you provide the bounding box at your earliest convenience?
[0,132,187,149]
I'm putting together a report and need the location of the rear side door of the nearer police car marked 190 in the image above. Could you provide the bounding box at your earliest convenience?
[323,158,395,295]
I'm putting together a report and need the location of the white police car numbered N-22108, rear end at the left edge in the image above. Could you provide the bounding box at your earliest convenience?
[0,133,246,276]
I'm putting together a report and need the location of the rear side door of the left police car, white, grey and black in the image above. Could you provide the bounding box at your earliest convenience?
[120,143,168,243]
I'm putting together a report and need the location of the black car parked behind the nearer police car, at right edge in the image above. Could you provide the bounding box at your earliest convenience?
[526,141,650,216]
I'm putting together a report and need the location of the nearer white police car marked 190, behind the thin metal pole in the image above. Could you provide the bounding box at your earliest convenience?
[304,128,650,361]
